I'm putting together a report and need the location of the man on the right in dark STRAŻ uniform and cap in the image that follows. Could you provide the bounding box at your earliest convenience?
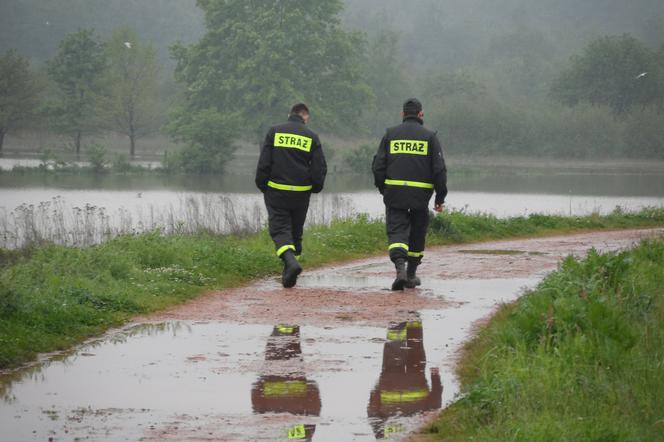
[373,98,447,290]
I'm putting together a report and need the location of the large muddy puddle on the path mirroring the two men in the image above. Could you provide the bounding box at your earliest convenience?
[0,278,534,441]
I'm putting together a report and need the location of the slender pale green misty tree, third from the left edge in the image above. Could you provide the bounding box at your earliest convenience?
[104,28,160,158]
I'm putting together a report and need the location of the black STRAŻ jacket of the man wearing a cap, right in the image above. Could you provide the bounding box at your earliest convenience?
[373,117,447,209]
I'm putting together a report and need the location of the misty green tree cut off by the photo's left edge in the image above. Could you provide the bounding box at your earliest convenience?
[0,50,38,155]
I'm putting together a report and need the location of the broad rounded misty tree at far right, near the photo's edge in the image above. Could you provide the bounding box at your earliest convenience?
[551,34,658,114]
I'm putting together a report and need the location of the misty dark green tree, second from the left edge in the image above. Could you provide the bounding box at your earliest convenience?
[48,29,107,156]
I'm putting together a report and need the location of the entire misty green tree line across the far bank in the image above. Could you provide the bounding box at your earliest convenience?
[0,0,664,173]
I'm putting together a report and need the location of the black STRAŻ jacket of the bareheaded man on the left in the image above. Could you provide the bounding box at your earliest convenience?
[256,115,327,207]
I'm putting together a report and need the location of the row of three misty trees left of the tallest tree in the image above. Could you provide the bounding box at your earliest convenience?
[0,28,160,157]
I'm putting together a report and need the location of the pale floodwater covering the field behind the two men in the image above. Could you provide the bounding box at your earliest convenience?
[0,169,664,248]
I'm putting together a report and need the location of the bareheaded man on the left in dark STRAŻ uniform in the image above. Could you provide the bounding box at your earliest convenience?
[256,103,327,287]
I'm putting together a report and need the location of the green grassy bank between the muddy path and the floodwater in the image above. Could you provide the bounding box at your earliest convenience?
[0,209,664,368]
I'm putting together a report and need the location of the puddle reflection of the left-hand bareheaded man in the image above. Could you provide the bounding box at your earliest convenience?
[251,325,321,441]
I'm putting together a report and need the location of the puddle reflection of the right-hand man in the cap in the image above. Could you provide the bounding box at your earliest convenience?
[367,319,443,439]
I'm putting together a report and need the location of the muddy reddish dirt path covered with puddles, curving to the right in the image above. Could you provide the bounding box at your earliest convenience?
[0,229,664,441]
